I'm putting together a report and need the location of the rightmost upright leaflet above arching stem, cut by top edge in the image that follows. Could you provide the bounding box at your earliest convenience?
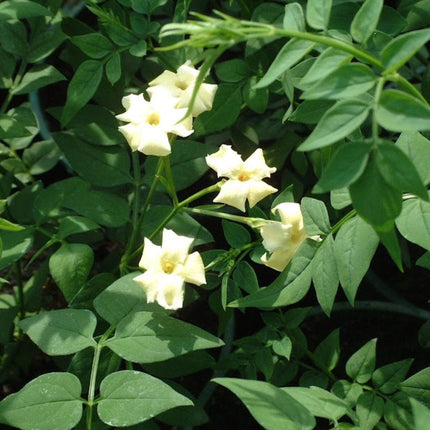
[351,0,384,44]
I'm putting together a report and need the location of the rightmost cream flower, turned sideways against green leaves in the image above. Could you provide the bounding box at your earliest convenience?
[260,203,320,272]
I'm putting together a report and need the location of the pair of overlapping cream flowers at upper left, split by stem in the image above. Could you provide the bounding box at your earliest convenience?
[116,62,217,157]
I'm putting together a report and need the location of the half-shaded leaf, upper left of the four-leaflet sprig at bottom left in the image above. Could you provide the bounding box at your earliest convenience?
[19,309,97,355]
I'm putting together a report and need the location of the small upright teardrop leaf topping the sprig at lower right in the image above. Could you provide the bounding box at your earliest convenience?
[345,339,377,384]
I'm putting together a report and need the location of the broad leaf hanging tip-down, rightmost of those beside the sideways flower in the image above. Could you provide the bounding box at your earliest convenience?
[334,216,379,304]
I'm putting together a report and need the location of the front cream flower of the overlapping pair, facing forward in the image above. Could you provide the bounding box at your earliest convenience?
[116,94,193,157]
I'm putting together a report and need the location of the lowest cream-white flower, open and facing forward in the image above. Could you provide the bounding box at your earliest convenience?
[133,228,206,309]
